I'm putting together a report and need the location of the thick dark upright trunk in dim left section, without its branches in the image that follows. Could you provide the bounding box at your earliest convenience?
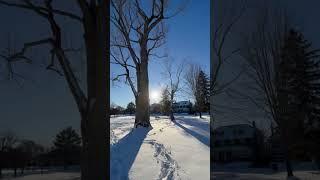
[81,1,110,180]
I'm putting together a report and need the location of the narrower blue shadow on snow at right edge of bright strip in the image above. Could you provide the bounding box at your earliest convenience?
[173,118,210,147]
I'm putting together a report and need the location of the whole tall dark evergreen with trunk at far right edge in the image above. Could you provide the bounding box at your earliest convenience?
[278,29,320,173]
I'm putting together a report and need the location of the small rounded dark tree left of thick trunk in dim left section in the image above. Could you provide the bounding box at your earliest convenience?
[53,127,81,168]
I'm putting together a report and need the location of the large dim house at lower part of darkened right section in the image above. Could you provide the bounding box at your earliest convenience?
[213,124,263,162]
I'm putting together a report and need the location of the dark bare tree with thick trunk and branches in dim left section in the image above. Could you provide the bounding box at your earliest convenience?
[0,0,110,180]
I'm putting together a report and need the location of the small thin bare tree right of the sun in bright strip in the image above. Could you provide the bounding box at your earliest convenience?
[163,59,184,121]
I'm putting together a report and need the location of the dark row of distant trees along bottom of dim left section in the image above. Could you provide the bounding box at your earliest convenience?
[0,127,81,178]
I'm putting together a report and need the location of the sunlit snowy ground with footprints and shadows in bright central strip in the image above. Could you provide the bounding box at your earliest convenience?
[110,115,210,180]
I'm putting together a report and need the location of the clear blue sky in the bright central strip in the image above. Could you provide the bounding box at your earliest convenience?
[110,0,210,106]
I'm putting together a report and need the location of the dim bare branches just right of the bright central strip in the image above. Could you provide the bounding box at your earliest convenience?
[210,0,247,125]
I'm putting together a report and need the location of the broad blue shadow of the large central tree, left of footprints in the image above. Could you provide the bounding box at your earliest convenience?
[110,128,151,180]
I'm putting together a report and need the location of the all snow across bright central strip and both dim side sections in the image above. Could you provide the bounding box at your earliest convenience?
[4,115,320,180]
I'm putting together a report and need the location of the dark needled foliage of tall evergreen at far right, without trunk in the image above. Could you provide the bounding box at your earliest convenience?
[280,29,320,133]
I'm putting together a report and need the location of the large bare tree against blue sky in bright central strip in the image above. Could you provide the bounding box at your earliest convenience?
[111,0,185,127]
